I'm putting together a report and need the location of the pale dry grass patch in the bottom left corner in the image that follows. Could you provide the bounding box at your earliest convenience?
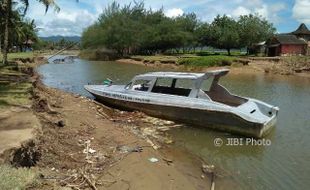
[0,165,38,190]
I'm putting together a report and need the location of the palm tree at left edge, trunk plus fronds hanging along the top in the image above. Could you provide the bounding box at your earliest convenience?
[1,0,60,64]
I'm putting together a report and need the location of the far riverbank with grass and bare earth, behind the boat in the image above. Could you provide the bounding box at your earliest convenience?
[117,55,310,77]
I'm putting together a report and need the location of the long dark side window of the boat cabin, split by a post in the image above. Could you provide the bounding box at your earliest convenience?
[152,78,193,96]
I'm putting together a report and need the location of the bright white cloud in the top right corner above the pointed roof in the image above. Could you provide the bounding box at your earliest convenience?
[293,0,310,24]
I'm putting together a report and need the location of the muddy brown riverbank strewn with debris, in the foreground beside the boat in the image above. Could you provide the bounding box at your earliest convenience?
[1,60,227,189]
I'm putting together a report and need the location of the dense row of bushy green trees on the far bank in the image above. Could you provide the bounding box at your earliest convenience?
[82,2,276,56]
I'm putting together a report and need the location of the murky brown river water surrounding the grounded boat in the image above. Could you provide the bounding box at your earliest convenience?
[38,56,310,190]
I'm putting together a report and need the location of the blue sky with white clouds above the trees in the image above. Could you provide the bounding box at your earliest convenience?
[27,0,310,37]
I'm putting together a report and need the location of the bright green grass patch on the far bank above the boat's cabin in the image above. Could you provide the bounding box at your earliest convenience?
[178,55,236,67]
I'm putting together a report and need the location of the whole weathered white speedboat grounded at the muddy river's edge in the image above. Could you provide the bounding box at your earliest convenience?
[84,69,279,138]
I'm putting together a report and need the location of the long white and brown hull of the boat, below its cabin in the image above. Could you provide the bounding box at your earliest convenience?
[85,85,277,138]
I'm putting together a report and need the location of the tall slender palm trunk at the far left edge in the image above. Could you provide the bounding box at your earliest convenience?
[3,0,12,65]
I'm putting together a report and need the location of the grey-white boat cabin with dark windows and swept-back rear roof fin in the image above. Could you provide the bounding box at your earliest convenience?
[125,69,247,106]
